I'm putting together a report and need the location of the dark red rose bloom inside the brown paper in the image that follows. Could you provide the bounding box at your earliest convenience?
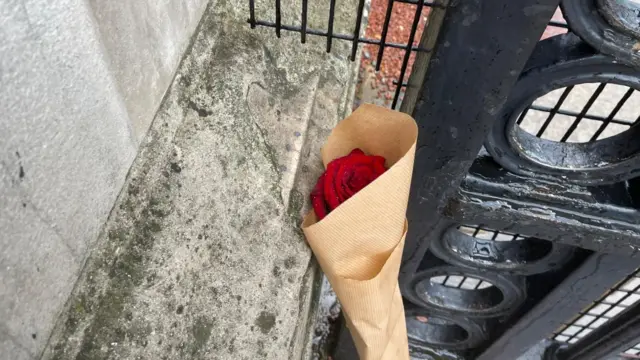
[311,149,387,220]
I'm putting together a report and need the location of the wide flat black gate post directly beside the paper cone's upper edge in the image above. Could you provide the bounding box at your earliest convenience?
[400,0,560,282]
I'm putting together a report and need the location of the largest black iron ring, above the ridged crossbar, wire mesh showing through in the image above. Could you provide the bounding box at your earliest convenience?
[485,34,640,185]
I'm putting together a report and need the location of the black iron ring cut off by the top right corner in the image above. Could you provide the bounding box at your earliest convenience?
[560,0,640,66]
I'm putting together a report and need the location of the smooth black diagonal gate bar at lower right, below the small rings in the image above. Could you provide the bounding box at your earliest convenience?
[478,254,640,360]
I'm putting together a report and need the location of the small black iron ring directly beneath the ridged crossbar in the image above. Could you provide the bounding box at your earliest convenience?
[429,227,574,275]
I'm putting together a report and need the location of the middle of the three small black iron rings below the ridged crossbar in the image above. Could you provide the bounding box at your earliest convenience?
[411,258,526,318]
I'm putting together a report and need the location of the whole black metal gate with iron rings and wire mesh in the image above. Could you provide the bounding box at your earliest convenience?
[249,0,640,360]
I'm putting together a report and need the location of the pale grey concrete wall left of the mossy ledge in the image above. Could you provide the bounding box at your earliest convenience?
[0,0,207,360]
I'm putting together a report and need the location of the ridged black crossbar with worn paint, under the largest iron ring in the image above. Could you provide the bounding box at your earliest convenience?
[452,157,640,256]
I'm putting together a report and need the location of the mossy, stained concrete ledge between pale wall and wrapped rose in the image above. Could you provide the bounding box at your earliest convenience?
[43,0,356,360]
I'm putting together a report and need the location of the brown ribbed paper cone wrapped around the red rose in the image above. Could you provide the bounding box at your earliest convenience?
[302,105,418,360]
